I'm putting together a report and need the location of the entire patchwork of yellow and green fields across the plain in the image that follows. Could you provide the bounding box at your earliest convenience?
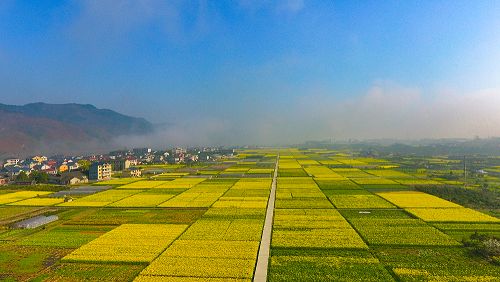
[0,148,500,281]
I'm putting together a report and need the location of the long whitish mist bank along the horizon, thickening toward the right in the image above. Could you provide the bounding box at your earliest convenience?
[115,83,500,147]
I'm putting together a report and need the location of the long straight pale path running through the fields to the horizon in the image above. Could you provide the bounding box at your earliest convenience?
[253,155,280,282]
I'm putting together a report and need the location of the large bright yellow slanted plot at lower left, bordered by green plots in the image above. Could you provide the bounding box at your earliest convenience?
[63,224,187,262]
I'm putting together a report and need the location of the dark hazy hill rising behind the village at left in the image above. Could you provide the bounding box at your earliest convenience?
[0,103,154,156]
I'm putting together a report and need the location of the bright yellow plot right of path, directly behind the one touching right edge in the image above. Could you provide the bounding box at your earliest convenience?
[377,191,462,208]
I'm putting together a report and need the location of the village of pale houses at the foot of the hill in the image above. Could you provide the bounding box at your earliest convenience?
[0,147,233,185]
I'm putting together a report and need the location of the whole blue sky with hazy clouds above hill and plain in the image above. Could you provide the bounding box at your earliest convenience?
[0,0,500,143]
